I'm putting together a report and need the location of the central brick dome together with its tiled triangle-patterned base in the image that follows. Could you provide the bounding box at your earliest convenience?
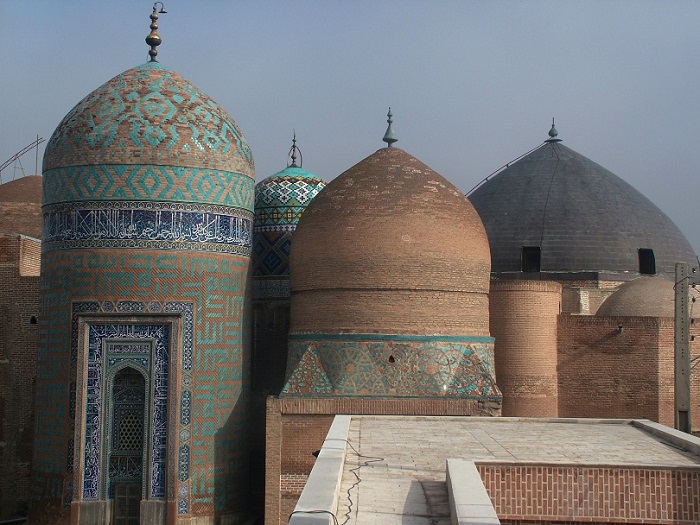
[282,133,500,400]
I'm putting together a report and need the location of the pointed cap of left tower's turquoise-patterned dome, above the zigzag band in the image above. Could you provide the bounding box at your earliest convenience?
[43,62,254,177]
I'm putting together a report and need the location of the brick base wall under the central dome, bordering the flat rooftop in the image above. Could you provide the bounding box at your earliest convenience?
[265,396,500,525]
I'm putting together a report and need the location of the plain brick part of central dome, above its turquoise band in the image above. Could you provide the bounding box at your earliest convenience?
[290,147,490,336]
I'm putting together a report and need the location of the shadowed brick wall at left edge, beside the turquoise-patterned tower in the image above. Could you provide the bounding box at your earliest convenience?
[0,234,40,519]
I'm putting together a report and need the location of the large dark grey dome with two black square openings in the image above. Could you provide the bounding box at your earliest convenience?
[469,139,695,279]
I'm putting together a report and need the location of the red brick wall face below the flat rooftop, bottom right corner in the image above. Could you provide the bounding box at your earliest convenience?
[477,464,700,524]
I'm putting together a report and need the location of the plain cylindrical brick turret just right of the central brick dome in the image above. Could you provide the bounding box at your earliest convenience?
[490,280,562,417]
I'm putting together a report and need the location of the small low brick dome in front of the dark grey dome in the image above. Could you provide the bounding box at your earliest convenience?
[596,276,675,317]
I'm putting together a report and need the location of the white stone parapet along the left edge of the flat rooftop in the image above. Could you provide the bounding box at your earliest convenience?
[289,416,352,525]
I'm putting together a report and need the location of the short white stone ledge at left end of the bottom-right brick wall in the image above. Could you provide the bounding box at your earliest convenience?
[446,459,501,525]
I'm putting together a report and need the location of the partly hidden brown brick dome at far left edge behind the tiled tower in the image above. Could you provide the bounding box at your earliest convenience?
[0,175,41,239]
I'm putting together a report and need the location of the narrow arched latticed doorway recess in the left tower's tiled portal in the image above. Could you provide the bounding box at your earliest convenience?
[107,367,147,525]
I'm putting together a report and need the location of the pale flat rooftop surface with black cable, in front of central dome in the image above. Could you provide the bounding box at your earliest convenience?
[332,416,700,525]
